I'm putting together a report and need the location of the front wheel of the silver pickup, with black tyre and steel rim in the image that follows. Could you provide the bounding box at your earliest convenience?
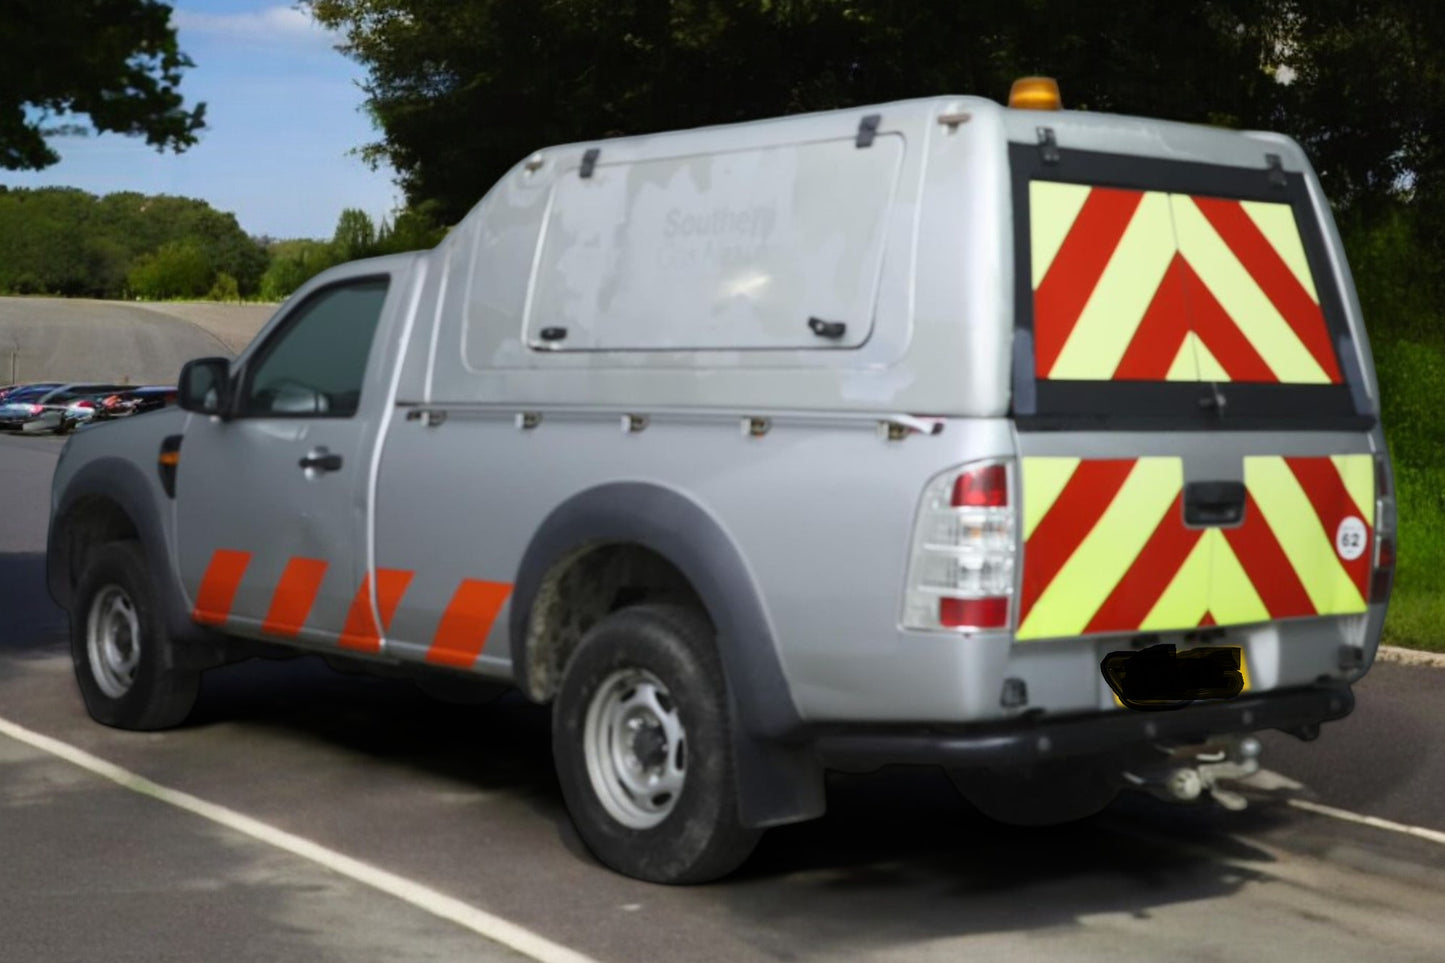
[71,541,201,730]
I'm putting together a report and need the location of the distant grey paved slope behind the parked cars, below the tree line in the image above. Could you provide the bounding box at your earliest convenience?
[0,298,275,385]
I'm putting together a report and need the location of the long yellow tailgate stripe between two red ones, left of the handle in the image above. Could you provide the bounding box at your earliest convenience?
[1017,457,1183,639]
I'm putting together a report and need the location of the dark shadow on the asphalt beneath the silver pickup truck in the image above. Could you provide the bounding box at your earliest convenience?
[177,656,1279,942]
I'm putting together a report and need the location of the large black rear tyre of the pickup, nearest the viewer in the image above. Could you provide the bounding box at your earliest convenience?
[552,603,762,883]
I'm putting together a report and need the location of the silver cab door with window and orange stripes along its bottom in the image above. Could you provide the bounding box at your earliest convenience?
[175,272,402,651]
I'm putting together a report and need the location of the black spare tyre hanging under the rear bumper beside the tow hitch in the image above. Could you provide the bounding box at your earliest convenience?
[948,759,1121,827]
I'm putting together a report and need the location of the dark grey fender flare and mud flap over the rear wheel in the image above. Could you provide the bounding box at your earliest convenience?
[509,482,824,827]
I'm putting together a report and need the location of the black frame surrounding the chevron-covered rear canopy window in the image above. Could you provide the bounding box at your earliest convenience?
[1009,143,1376,431]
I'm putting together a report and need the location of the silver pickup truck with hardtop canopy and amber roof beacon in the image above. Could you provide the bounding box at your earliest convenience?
[48,91,1394,882]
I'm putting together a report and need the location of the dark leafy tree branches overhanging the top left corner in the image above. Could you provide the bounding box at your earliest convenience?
[0,0,205,169]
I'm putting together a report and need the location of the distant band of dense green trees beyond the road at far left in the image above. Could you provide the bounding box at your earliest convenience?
[0,188,269,298]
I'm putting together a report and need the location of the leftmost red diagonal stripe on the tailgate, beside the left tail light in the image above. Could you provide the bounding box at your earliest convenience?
[1019,458,1136,625]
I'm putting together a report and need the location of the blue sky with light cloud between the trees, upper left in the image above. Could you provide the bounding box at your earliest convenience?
[0,0,402,239]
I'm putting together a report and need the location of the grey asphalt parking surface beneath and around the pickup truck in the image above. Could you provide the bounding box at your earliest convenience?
[0,438,1445,963]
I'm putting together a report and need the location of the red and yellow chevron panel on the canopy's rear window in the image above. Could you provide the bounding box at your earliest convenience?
[1029,181,1341,385]
